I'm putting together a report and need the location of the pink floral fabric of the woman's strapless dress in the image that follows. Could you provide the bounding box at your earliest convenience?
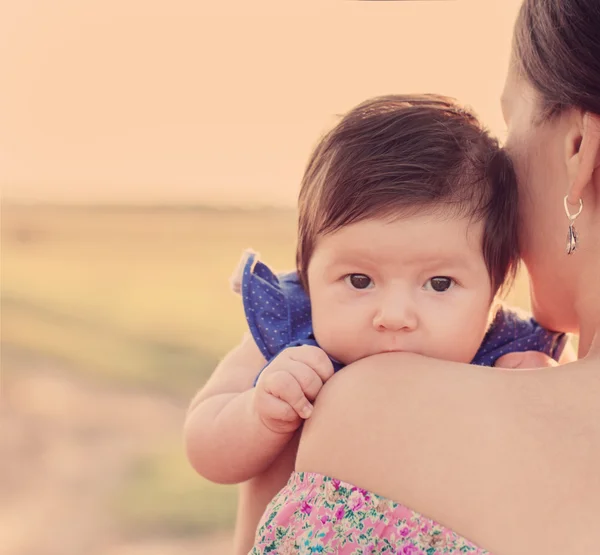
[250,472,491,555]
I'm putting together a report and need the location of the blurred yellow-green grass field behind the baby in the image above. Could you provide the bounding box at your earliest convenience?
[1,206,527,548]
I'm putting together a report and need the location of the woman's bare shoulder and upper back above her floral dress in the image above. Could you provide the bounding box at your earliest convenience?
[296,353,600,553]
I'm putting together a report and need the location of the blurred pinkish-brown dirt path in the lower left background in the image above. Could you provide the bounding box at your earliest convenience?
[0,353,230,555]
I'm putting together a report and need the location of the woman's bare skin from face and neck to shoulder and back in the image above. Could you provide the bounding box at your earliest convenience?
[296,63,600,555]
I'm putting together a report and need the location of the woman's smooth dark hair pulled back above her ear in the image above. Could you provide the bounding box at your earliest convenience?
[513,0,600,118]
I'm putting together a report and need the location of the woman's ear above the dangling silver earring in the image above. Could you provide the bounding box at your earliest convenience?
[565,112,600,206]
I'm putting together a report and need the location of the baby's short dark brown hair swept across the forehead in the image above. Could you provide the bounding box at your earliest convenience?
[296,95,519,294]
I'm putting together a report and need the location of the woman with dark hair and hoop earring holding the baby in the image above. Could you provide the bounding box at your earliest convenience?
[255,0,600,555]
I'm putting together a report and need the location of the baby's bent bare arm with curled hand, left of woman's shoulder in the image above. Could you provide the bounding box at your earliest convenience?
[184,336,333,483]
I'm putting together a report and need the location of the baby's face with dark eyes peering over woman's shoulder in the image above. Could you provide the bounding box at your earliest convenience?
[308,214,492,364]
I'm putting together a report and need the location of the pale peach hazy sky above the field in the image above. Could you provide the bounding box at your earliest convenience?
[0,0,520,206]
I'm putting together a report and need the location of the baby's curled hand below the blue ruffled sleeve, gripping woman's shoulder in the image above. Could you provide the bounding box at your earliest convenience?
[254,345,333,433]
